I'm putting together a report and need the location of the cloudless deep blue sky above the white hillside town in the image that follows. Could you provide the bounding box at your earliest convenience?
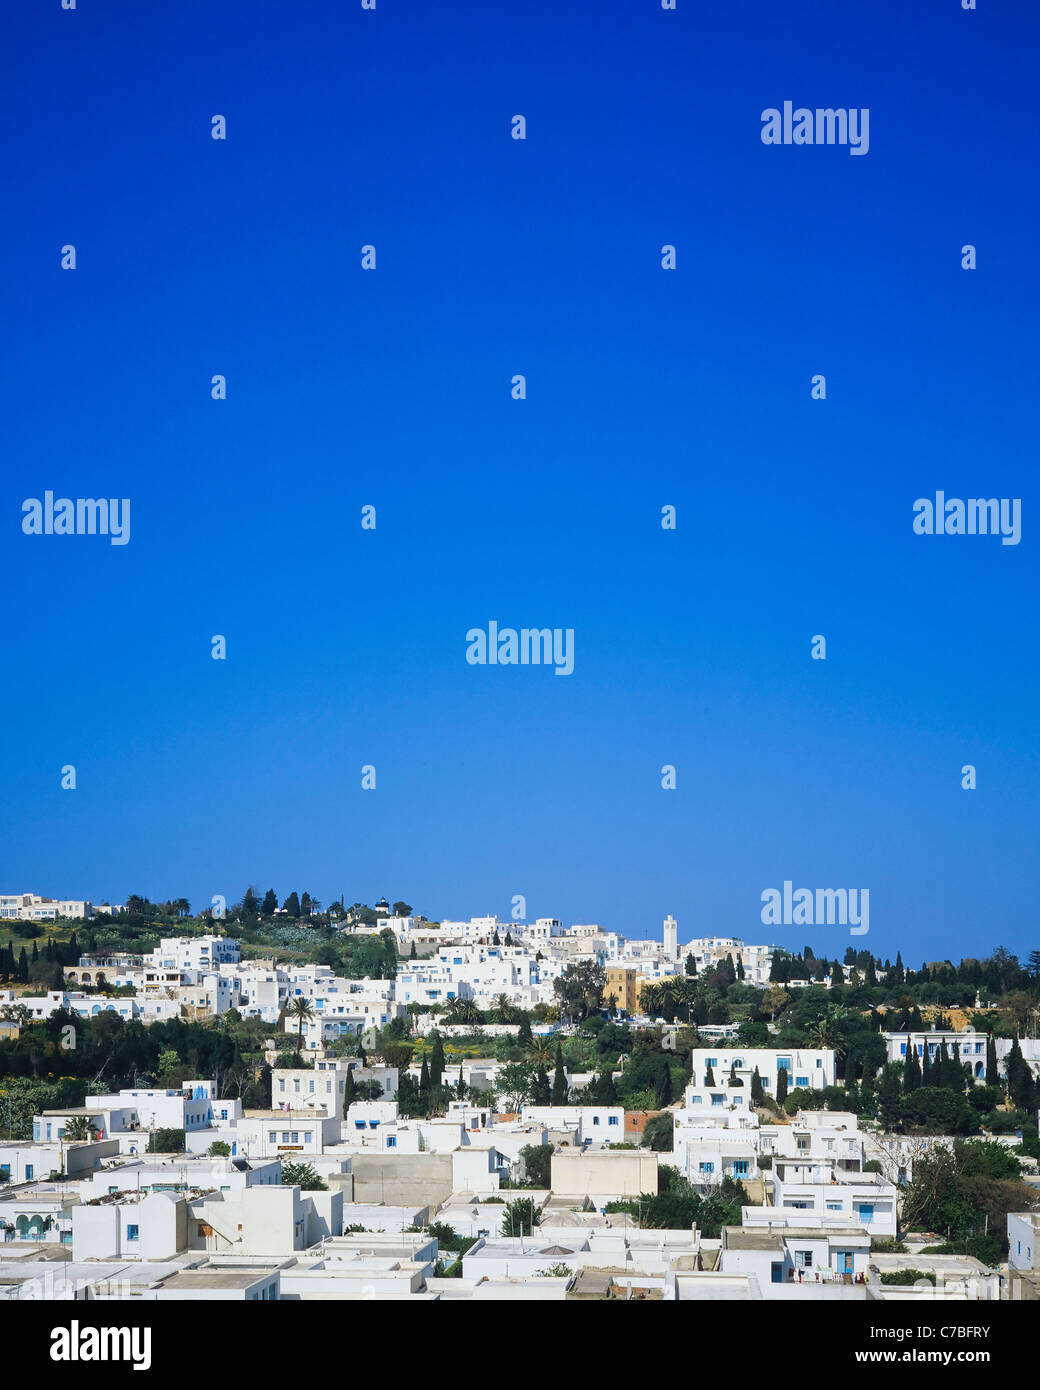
[0,0,1040,962]
